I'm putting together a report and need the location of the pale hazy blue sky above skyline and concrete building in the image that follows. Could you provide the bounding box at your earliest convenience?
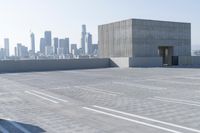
[0,0,200,54]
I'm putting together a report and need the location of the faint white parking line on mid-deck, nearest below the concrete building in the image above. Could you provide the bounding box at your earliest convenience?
[113,82,167,90]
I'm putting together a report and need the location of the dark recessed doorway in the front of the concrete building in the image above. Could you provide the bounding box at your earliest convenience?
[158,46,173,66]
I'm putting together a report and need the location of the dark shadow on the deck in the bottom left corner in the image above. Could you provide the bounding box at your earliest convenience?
[0,119,46,133]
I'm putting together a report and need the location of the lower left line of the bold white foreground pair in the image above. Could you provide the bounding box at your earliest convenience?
[83,107,181,133]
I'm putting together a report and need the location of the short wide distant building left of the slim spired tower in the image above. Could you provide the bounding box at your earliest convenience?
[15,43,29,58]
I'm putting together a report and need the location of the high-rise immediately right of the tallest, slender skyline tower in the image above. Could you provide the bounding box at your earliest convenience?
[85,33,92,55]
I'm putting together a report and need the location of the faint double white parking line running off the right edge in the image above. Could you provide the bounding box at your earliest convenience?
[149,97,200,107]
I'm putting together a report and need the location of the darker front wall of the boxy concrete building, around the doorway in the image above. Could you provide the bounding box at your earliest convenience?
[133,19,191,57]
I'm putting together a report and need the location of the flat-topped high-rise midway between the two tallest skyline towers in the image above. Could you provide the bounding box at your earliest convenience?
[59,38,69,55]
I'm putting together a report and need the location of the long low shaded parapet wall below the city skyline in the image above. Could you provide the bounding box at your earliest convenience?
[0,58,110,73]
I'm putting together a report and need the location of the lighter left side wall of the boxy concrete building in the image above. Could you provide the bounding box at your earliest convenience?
[98,20,132,58]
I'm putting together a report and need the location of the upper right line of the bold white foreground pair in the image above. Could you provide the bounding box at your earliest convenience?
[94,105,200,133]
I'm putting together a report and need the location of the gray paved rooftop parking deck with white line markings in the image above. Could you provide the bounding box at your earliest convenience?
[0,68,200,133]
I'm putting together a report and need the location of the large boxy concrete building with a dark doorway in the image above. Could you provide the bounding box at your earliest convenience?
[98,19,191,66]
